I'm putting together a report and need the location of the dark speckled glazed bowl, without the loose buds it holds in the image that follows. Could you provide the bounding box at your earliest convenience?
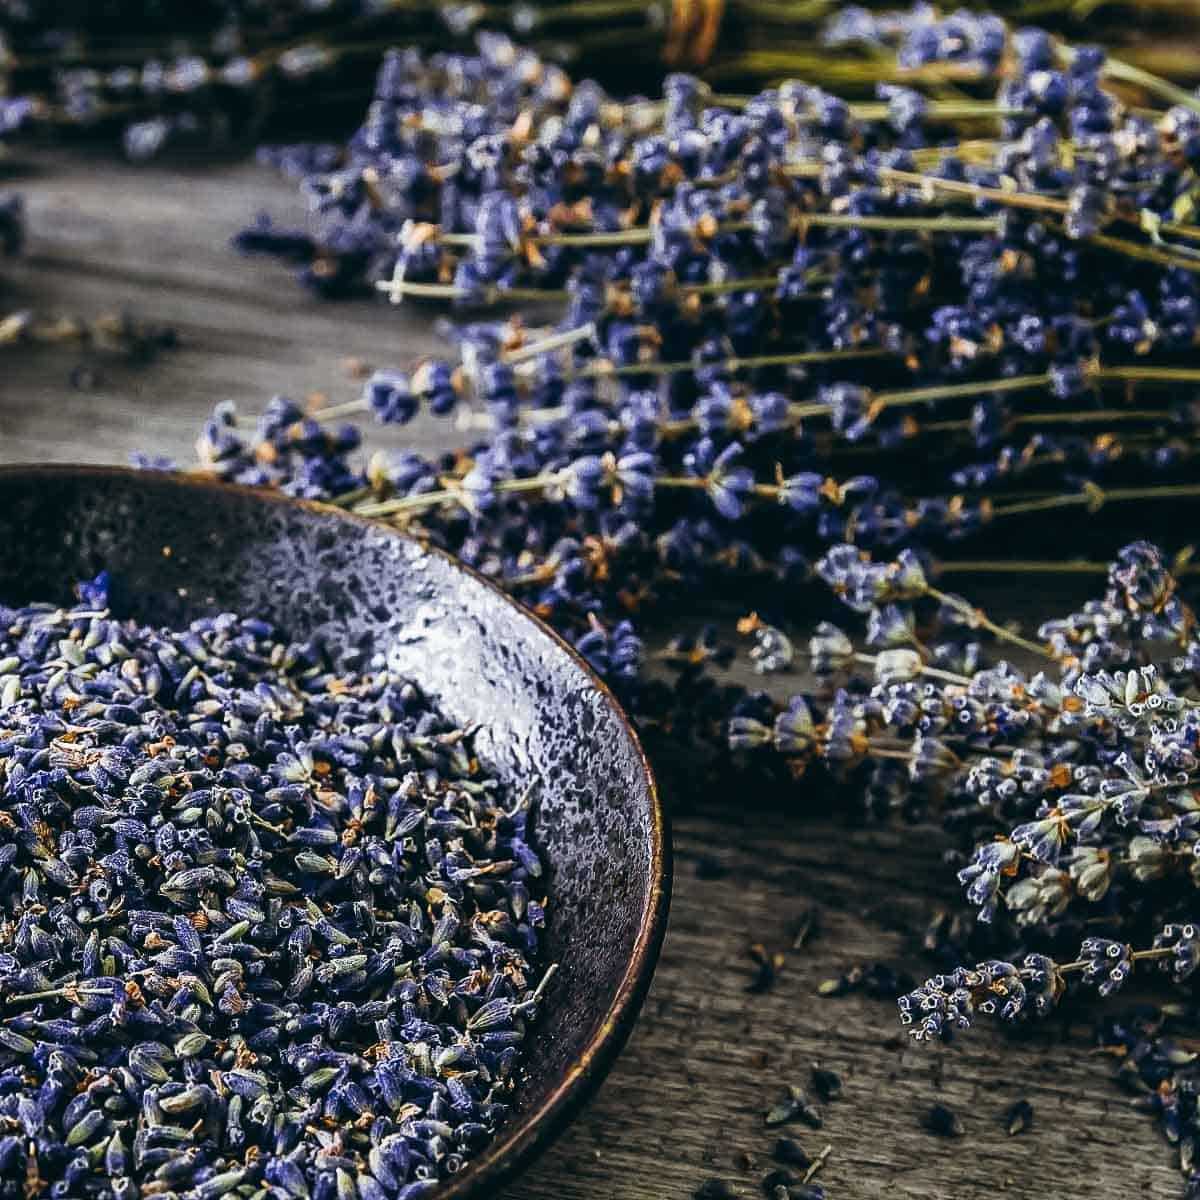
[0,467,671,1200]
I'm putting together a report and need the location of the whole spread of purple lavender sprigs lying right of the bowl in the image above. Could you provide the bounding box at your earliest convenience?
[180,14,1200,1193]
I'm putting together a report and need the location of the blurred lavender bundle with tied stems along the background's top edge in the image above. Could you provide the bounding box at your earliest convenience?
[7,0,1196,160]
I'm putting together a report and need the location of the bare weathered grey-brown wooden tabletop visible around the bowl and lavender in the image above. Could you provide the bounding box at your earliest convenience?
[0,151,1182,1200]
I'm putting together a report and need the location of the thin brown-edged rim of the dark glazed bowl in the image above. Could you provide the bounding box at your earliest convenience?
[0,463,672,1200]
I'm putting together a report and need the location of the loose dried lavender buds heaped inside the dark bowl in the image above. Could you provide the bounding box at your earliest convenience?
[0,577,553,1200]
